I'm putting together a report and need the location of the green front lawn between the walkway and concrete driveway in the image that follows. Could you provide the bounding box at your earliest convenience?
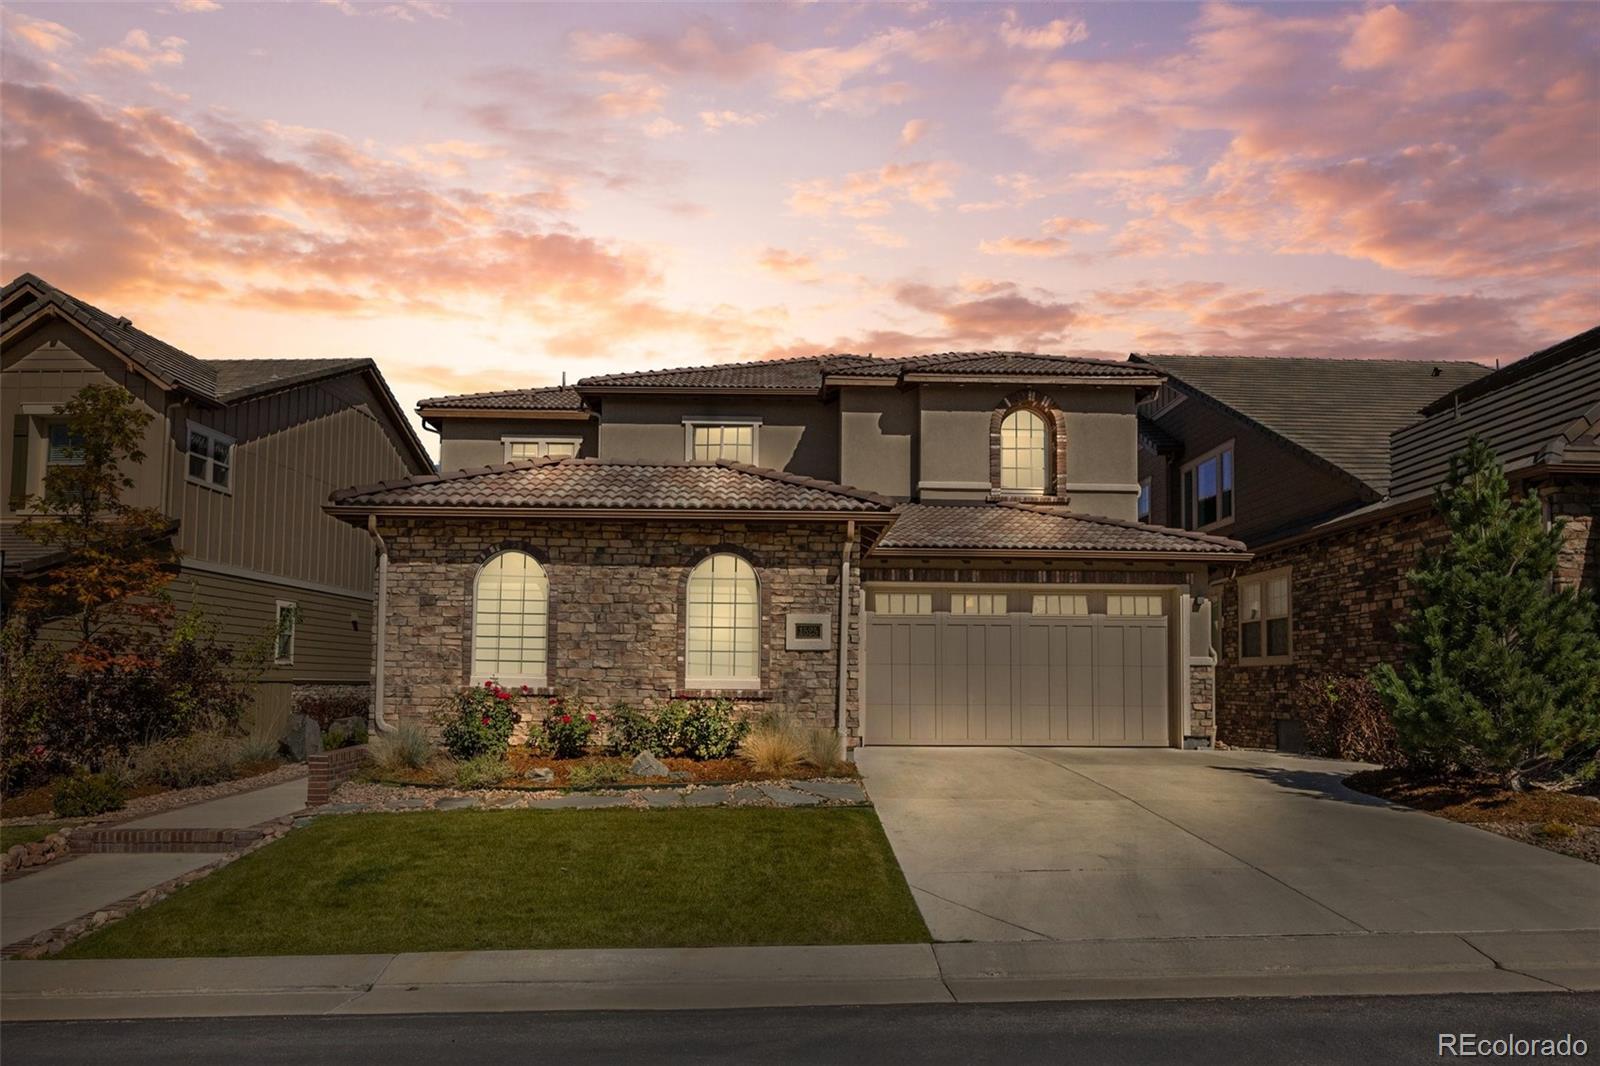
[59,808,928,959]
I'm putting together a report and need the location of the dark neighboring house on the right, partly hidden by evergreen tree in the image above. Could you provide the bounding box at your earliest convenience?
[1131,328,1600,747]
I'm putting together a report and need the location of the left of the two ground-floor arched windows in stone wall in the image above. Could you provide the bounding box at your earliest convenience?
[472,552,550,685]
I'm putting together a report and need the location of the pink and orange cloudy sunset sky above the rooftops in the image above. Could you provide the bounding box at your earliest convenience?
[0,0,1600,448]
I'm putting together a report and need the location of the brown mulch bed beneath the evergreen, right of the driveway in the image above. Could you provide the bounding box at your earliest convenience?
[1344,770,1600,863]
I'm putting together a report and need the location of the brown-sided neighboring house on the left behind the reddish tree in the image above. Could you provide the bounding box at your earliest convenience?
[0,274,432,730]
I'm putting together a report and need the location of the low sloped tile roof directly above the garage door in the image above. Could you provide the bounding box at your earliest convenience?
[874,501,1248,555]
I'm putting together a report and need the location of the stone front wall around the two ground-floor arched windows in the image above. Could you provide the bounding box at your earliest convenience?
[381,519,861,738]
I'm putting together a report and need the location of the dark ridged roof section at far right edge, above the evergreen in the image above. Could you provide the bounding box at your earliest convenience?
[1390,327,1600,498]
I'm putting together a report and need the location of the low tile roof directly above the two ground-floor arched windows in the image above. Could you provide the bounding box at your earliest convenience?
[331,459,894,515]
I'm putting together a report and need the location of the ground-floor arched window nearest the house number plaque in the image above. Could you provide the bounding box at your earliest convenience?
[683,552,762,688]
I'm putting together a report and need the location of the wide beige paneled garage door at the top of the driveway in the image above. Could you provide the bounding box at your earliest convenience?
[862,594,1168,746]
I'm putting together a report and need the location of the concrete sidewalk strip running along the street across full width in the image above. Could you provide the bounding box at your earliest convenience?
[0,930,1600,1021]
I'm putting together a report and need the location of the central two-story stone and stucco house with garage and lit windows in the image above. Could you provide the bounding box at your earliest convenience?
[337,352,1248,746]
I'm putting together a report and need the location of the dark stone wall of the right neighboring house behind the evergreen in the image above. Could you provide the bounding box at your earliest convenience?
[1216,479,1600,747]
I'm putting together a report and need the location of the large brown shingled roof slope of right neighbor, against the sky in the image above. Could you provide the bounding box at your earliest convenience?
[1130,354,1490,496]
